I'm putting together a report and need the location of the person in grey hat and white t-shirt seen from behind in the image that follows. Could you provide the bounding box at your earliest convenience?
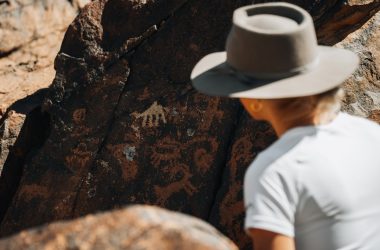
[191,3,380,250]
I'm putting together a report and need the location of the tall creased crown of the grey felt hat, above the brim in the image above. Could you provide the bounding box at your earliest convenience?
[226,3,318,79]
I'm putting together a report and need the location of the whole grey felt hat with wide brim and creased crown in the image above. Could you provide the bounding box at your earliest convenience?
[191,3,359,99]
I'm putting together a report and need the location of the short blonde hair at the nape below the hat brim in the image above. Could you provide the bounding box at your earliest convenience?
[270,87,344,125]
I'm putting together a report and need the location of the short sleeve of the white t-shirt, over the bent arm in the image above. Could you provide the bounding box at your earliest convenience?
[244,161,298,237]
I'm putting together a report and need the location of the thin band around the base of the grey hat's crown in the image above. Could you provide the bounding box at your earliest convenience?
[227,57,319,84]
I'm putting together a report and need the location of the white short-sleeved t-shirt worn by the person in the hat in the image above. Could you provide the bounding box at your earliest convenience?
[244,113,380,250]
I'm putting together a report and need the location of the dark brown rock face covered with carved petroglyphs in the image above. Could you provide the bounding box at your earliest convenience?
[0,0,379,249]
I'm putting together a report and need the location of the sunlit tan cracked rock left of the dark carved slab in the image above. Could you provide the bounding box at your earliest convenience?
[0,0,89,170]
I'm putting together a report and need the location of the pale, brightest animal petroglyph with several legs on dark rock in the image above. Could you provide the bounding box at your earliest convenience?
[132,102,167,128]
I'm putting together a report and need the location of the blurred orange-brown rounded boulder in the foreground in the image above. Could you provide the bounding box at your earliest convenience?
[0,206,238,250]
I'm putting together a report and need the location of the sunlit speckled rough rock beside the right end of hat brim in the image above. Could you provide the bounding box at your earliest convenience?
[337,12,380,123]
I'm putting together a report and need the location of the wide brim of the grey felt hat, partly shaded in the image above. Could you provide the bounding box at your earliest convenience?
[191,46,359,99]
